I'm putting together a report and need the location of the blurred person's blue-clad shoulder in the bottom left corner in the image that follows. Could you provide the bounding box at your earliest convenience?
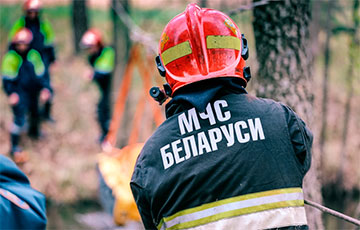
[0,154,47,229]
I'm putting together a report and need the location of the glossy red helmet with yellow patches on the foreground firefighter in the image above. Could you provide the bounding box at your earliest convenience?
[156,4,247,93]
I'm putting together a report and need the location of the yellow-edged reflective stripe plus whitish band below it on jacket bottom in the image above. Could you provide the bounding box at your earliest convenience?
[158,188,307,229]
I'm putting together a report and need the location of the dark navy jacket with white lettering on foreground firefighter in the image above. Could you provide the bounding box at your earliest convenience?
[130,78,312,229]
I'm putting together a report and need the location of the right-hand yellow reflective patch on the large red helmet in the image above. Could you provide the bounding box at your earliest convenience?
[206,35,241,50]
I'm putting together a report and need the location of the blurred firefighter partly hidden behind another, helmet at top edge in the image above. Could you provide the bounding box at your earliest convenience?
[9,0,56,121]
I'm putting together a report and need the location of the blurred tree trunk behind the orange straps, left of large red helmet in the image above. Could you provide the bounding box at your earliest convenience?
[111,0,131,147]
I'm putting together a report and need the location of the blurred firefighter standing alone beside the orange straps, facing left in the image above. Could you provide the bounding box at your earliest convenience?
[80,29,115,143]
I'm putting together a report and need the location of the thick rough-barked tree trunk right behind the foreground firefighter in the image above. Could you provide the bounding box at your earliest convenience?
[253,0,323,229]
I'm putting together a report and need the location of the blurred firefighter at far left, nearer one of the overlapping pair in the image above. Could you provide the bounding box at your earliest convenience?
[1,28,51,163]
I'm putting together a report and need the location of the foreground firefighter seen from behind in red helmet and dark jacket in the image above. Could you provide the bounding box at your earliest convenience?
[130,4,312,229]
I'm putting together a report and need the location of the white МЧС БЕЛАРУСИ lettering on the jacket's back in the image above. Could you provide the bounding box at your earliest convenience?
[160,100,265,169]
